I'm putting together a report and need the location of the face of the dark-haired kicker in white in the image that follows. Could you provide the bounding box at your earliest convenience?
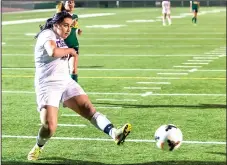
[56,18,73,39]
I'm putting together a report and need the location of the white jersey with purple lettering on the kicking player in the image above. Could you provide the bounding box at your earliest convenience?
[35,29,70,87]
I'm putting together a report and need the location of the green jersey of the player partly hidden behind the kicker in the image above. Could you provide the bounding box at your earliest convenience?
[65,14,79,48]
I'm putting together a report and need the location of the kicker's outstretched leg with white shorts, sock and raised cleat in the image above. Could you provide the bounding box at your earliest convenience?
[63,83,131,145]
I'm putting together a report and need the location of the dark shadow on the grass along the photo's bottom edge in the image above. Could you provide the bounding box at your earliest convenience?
[2,160,226,165]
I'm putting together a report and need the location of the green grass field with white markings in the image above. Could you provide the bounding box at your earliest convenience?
[2,8,226,165]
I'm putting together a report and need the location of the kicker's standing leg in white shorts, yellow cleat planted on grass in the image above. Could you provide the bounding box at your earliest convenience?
[27,89,63,160]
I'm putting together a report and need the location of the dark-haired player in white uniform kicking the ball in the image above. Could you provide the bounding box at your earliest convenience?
[27,11,131,160]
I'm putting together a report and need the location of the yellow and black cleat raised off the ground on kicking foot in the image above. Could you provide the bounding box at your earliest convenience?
[115,123,132,145]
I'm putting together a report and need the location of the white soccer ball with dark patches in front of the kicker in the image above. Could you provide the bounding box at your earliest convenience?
[154,124,183,151]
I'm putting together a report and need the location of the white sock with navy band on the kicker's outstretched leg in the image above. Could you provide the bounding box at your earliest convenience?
[90,112,116,139]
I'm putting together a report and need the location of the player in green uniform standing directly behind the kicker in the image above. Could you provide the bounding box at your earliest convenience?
[56,0,82,82]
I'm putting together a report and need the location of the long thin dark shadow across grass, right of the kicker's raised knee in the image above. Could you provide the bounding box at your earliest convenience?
[93,102,226,109]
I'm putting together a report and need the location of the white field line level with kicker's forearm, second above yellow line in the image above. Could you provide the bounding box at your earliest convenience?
[2,54,222,58]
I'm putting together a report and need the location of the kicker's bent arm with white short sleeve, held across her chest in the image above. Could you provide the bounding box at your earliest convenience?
[44,40,77,58]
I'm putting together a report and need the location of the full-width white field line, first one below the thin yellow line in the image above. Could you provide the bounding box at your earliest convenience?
[2,90,226,96]
